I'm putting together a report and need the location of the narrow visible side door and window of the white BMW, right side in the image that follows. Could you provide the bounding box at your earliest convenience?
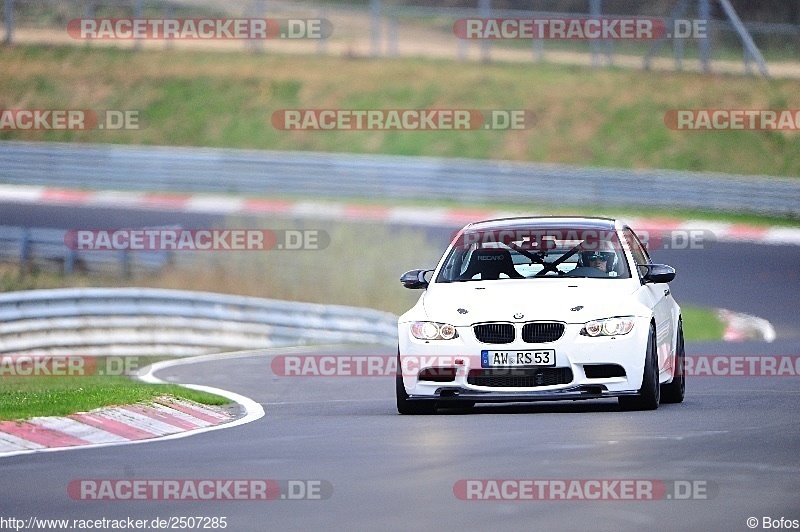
[623,227,675,371]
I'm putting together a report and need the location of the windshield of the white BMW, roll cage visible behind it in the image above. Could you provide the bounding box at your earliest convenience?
[436,227,630,283]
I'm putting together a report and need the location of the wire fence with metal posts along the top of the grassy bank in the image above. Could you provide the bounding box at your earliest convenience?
[3,0,800,77]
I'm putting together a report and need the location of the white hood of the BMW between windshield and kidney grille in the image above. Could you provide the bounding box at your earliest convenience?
[423,279,638,326]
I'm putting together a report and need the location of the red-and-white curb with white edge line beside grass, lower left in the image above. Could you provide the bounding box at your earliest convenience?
[0,352,264,458]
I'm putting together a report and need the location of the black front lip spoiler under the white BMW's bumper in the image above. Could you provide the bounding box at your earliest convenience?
[408,385,639,403]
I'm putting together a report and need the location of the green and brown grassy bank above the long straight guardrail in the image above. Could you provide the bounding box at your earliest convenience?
[0,46,800,176]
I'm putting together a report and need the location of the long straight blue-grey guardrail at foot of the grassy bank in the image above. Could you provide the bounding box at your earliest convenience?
[0,142,800,217]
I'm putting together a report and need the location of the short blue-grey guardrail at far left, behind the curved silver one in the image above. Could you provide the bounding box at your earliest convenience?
[0,225,172,275]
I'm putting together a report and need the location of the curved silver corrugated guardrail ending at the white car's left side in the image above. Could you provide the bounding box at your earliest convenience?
[0,288,397,356]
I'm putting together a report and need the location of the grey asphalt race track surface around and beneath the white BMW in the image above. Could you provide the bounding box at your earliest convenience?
[0,205,800,530]
